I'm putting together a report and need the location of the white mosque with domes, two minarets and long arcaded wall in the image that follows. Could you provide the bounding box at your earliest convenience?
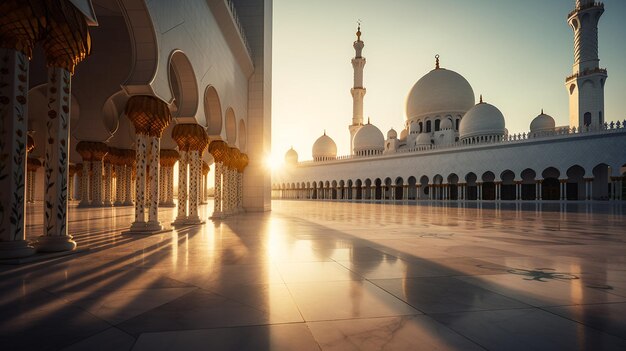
[272,0,626,201]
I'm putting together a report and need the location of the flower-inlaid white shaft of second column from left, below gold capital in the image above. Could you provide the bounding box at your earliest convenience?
[37,67,76,252]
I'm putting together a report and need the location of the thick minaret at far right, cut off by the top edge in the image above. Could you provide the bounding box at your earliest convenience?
[565,0,607,129]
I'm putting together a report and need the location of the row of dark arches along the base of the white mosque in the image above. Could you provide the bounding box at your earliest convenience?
[272,164,626,201]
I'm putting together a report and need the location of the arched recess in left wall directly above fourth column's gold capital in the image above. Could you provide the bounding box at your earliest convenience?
[168,50,199,122]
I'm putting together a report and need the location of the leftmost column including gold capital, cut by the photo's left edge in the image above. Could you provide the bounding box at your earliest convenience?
[0,1,42,258]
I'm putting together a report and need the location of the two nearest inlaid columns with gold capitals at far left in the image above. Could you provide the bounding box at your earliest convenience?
[0,0,91,258]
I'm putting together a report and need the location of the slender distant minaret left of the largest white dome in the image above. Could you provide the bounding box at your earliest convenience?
[348,23,365,155]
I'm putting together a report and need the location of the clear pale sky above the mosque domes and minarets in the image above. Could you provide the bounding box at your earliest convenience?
[272,0,626,165]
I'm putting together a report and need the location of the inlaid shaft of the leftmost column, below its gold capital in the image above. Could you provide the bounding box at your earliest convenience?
[0,49,35,258]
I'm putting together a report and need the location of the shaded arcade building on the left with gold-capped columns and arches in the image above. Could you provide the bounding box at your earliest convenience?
[0,0,272,258]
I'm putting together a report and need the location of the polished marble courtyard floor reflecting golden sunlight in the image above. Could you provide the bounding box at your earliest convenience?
[0,200,626,350]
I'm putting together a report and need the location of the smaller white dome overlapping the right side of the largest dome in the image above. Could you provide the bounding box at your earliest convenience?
[459,102,505,139]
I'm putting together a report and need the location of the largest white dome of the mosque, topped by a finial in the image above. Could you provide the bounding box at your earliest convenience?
[406,68,476,119]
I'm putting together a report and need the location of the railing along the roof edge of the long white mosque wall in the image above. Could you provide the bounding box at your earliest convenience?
[298,119,626,166]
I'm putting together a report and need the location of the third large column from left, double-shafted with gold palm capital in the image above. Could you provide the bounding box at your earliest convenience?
[125,95,172,234]
